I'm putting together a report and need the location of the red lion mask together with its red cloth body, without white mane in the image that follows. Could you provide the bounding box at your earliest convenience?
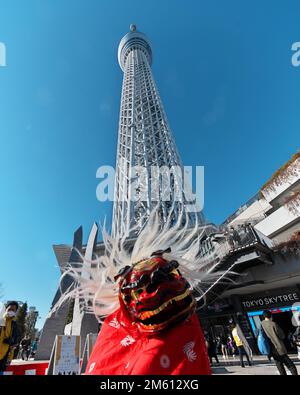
[86,252,211,375]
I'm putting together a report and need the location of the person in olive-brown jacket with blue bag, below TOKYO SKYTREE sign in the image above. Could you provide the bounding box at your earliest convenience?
[261,310,298,376]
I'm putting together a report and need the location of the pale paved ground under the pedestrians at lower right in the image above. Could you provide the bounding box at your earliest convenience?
[212,355,300,376]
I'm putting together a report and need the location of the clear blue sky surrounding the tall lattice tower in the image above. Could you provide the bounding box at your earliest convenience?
[0,0,300,326]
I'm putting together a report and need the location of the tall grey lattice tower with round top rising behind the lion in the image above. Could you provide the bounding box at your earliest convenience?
[112,25,204,236]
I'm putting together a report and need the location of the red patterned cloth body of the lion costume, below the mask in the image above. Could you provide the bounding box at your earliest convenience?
[85,308,211,375]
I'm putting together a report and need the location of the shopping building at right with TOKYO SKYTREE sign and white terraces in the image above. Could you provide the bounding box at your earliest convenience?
[199,153,300,352]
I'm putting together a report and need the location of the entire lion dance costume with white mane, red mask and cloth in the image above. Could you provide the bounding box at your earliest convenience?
[56,212,220,375]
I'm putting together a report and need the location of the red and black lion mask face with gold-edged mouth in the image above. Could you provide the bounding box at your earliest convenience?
[115,252,196,333]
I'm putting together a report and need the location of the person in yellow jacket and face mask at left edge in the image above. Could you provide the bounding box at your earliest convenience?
[0,301,19,375]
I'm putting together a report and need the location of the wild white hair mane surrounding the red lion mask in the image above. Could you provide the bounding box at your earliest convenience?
[50,208,230,322]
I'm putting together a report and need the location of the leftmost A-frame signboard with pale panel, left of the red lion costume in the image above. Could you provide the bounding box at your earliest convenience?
[47,335,80,376]
